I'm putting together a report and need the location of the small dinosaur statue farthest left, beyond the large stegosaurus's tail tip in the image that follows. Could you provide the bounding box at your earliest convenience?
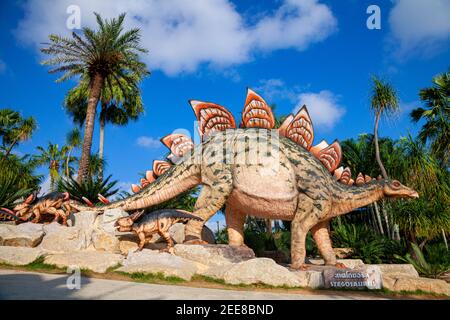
[13,192,71,225]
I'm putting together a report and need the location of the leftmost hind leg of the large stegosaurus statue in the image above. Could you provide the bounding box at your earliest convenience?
[185,183,231,244]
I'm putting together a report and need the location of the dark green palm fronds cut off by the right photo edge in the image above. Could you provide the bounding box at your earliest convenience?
[411,70,450,166]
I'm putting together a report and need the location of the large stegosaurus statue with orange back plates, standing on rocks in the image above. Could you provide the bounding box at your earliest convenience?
[71,89,419,268]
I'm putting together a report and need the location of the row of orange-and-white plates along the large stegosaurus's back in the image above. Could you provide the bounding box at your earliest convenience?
[125,89,368,195]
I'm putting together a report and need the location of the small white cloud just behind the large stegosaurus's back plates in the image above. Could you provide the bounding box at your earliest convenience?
[293,90,345,130]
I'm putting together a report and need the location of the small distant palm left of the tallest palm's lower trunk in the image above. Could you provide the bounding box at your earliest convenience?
[33,142,69,190]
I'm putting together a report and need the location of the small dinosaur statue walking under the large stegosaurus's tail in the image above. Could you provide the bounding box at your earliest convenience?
[115,209,202,251]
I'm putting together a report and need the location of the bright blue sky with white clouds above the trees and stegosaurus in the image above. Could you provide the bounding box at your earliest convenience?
[0,0,450,230]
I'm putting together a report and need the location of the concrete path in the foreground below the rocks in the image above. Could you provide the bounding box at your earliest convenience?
[0,270,386,300]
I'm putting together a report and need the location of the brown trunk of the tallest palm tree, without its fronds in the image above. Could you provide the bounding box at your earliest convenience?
[77,73,105,182]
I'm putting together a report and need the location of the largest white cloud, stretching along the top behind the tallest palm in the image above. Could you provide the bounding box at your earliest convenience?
[16,0,337,75]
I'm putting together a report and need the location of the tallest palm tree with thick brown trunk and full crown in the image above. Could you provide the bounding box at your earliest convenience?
[41,13,148,181]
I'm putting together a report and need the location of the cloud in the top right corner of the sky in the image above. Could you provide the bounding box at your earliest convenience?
[389,0,450,56]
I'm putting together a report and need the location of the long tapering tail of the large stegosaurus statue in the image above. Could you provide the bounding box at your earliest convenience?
[71,155,201,211]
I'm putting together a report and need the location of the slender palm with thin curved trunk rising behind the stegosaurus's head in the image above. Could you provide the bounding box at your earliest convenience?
[370,76,399,179]
